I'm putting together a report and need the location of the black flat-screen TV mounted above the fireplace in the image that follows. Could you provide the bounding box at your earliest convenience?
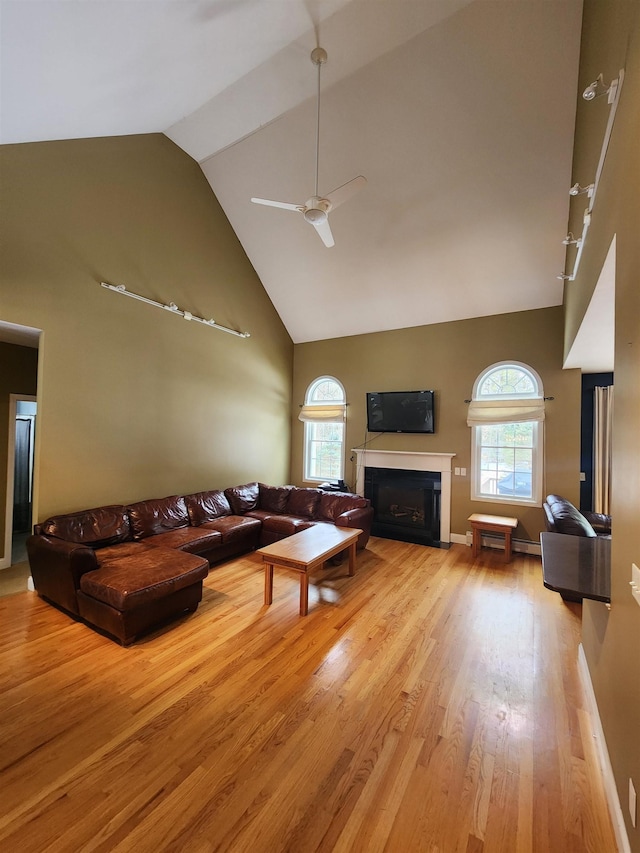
[367,391,435,433]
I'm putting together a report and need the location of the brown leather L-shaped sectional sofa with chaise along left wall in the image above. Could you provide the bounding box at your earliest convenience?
[27,483,373,645]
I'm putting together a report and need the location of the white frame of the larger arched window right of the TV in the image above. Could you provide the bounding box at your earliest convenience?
[471,361,544,507]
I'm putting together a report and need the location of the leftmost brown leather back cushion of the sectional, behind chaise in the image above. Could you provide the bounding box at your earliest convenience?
[40,504,131,548]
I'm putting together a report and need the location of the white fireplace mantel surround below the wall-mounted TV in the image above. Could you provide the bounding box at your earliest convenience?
[352,448,456,542]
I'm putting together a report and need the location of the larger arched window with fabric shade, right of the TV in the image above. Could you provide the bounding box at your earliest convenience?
[467,362,544,506]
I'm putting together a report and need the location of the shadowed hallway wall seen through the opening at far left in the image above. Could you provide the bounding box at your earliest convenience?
[0,341,38,562]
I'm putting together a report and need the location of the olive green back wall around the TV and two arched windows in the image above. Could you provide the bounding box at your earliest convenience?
[292,308,580,542]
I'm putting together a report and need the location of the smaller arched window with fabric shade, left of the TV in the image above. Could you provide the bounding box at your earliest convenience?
[299,376,347,483]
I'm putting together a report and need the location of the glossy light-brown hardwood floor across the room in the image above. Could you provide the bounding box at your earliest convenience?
[0,539,616,853]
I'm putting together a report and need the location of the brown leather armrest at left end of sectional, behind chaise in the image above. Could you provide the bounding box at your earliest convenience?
[27,535,98,613]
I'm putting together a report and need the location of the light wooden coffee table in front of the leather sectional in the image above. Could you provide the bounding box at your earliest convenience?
[258,524,362,616]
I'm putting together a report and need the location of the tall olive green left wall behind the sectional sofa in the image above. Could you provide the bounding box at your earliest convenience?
[0,134,293,532]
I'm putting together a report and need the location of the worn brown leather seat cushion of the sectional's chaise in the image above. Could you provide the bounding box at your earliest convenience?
[80,548,209,611]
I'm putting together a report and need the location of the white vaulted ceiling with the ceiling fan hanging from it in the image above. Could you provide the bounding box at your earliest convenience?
[0,0,596,352]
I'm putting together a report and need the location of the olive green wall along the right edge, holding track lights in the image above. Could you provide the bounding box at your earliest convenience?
[566,0,640,853]
